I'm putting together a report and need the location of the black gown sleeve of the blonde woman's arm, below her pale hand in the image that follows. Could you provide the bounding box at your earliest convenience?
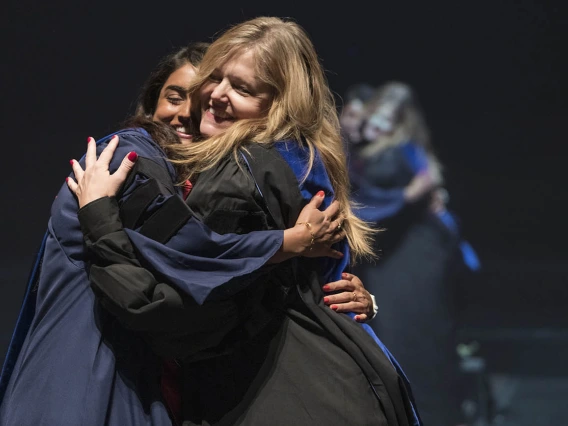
[79,197,239,358]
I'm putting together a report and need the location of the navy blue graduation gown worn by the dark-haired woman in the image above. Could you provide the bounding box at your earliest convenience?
[0,130,282,426]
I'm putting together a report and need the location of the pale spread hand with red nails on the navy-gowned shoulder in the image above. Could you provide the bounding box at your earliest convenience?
[67,135,138,208]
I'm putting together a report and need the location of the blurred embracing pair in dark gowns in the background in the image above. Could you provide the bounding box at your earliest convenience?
[349,82,479,426]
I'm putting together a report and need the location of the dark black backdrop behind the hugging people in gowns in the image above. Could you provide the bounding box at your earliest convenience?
[0,0,568,425]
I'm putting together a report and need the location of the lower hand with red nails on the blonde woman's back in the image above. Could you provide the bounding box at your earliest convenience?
[323,272,374,322]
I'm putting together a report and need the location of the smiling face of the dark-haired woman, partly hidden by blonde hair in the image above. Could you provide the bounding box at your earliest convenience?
[152,63,195,144]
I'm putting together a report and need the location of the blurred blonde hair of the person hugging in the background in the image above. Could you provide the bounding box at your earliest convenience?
[360,81,443,185]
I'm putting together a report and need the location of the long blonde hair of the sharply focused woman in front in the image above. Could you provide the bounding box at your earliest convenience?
[164,17,375,260]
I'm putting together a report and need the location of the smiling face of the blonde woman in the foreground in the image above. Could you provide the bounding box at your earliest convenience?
[199,50,272,136]
